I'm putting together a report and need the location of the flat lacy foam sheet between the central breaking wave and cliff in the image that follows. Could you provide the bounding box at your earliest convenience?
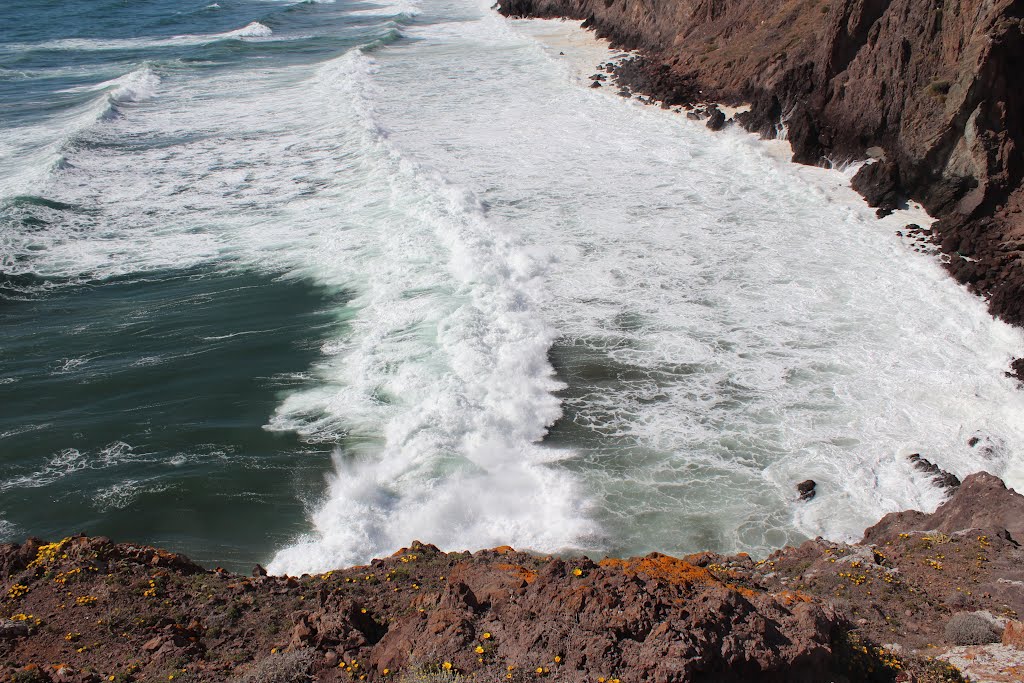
[299,3,1024,552]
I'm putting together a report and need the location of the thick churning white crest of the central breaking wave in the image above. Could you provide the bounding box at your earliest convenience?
[270,51,591,572]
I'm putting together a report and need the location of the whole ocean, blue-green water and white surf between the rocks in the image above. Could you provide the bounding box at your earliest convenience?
[0,0,1024,573]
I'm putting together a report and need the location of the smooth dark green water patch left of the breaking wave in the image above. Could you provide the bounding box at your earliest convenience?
[0,269,345,569]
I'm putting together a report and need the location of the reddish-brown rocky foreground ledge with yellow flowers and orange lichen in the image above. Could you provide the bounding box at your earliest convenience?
[0,473,1024,683]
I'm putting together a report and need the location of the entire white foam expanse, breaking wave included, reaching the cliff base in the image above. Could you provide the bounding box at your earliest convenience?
[0,0,1024,572]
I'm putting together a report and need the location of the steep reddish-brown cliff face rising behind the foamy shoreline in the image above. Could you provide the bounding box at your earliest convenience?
[501,0,1024,325]
